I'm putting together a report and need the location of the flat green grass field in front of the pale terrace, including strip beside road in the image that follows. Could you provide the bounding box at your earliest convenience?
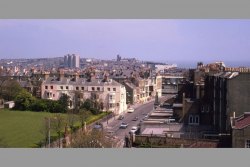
[0,109,106,148]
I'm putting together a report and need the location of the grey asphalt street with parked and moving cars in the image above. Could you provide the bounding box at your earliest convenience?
[102,95,173,143]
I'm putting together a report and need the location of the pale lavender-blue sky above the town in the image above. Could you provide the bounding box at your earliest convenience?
[0,19,250,65]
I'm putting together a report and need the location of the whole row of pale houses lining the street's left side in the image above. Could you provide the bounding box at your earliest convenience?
[41,71,161,115]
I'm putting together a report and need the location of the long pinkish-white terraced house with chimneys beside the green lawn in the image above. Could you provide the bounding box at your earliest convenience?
[41,74,127,115]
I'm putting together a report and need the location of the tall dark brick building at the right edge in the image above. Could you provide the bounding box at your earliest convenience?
[201,72,250,133]
